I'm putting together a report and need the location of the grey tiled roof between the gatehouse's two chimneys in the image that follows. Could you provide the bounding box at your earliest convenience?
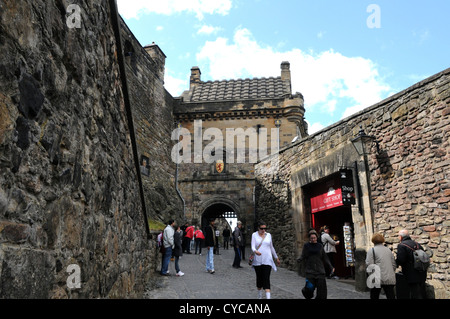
[183,77,290,102]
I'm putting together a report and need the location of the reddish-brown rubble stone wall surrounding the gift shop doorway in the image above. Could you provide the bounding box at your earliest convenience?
[255,69,450,298]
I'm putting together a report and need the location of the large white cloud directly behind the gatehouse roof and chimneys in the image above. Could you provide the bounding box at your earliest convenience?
[197,28,392,117]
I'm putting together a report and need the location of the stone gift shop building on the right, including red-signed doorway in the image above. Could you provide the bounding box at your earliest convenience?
[255,69,450,299]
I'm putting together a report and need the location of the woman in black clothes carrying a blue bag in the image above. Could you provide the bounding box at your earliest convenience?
[297,230,334,299]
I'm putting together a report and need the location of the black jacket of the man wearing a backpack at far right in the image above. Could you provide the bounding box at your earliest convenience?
[395,236,427,284]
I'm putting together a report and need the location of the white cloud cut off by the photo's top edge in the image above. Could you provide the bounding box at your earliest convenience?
[117,0,232,20]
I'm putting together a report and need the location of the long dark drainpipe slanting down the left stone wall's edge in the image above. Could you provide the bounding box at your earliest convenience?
[109,0,151,238]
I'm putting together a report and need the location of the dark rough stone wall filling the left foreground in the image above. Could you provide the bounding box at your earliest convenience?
[0,0,150,298]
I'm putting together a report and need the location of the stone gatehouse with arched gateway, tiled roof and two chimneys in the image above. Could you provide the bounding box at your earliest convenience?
[174,62,307,235]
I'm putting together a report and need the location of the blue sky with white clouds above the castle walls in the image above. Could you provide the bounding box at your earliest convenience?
[117,0,450,134]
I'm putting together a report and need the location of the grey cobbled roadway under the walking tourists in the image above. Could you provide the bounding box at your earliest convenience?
[146,249,374,299]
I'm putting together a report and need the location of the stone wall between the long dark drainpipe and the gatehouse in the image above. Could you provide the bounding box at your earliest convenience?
[121,21,183,223]
